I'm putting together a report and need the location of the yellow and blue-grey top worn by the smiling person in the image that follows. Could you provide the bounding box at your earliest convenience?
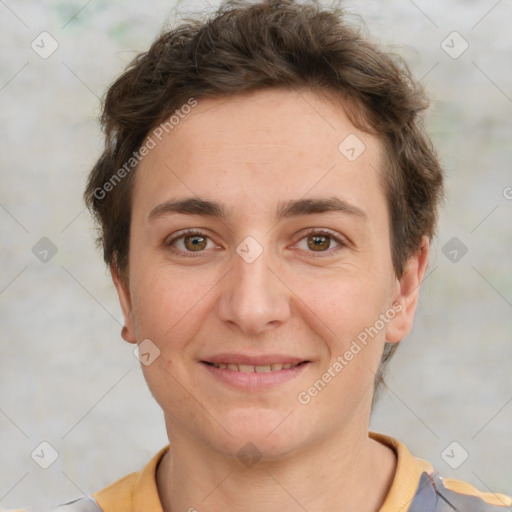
[45,432,512,512]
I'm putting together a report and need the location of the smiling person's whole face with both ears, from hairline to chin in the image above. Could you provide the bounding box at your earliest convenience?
[112,89,428,458]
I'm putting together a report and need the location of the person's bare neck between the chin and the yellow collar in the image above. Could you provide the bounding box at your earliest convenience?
[157,432,396,512]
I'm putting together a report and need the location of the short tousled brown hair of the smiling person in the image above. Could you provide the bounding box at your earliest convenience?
[84,0,443,401]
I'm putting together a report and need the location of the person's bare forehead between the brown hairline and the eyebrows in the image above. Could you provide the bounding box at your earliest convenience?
[134,89,383,221]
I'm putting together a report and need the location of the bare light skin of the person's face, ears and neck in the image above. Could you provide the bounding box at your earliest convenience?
[111,89,429,512]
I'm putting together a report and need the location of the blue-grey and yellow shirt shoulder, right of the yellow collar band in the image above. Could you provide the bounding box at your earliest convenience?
[408,472,512,512]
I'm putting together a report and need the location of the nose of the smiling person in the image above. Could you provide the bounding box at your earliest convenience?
[218,240,291,335]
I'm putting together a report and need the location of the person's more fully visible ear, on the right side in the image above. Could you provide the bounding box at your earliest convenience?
[386,236,430,343]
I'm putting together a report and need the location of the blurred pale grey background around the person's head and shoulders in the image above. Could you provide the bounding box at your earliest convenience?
[0,0,512,509]
